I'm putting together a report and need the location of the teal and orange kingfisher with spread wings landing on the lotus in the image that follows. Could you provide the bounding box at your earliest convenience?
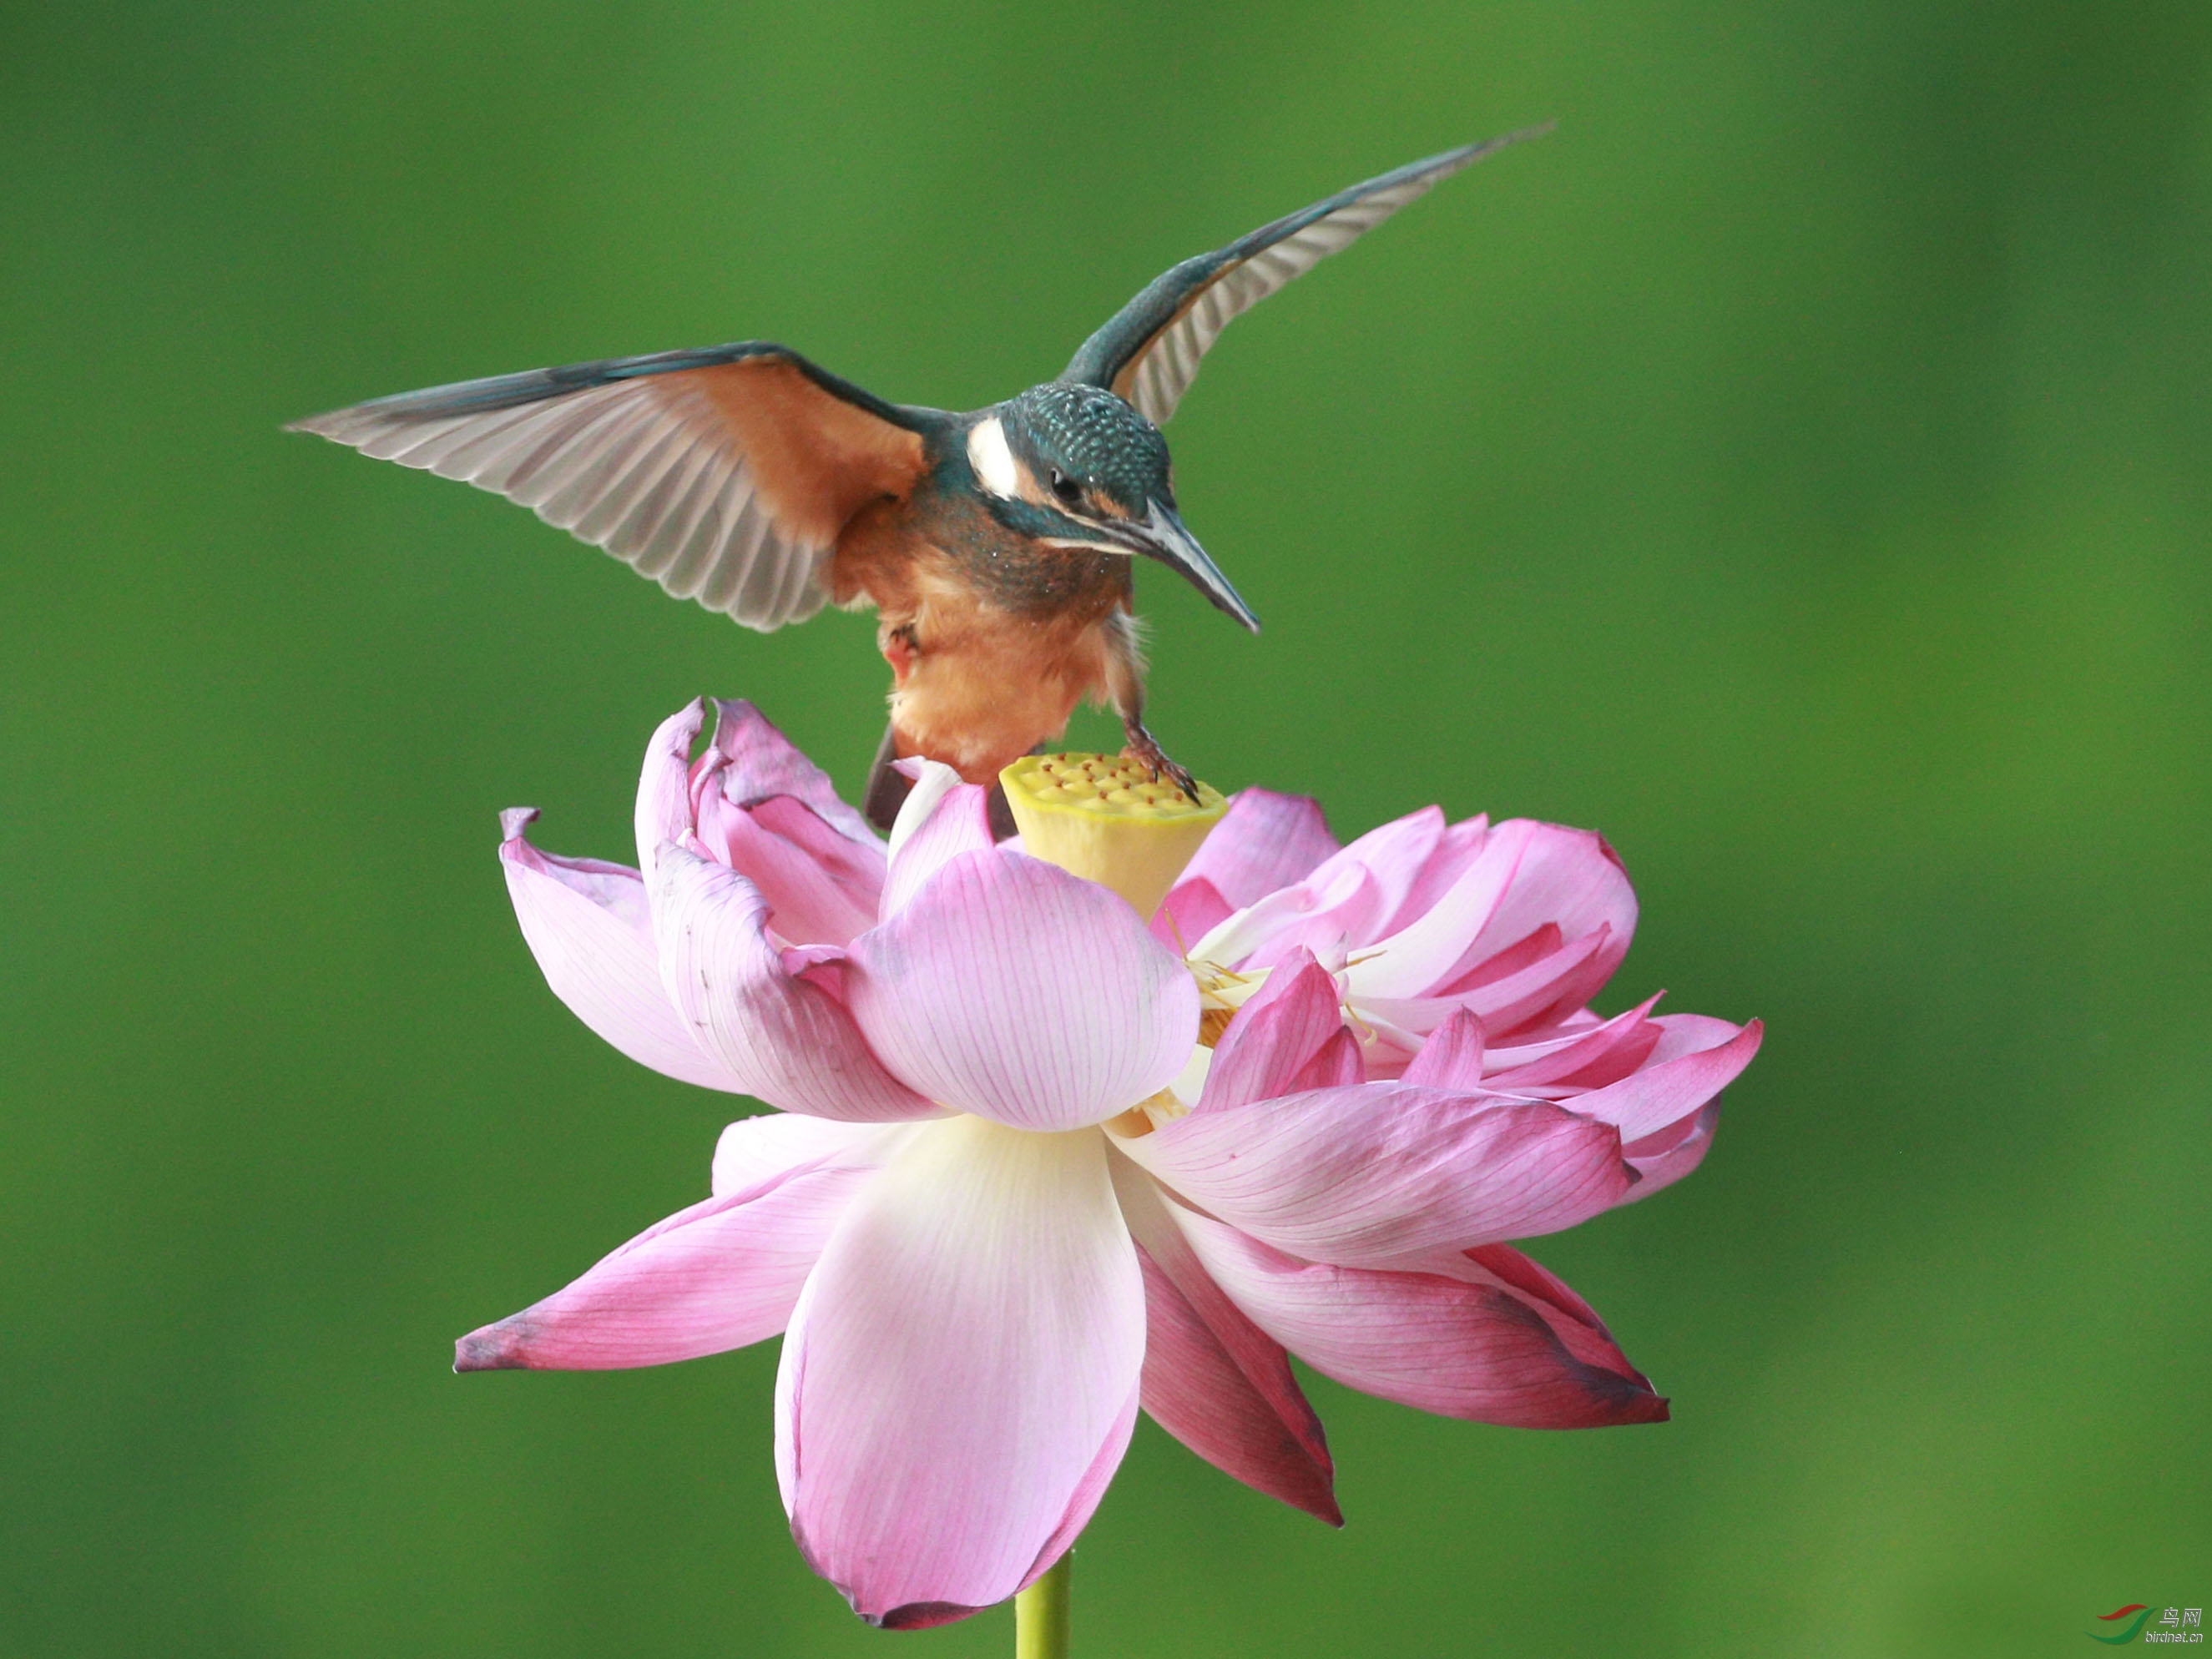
[288,129,1546,830]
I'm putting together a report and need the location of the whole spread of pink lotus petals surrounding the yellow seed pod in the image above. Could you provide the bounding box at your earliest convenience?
[471,703,1759,1628]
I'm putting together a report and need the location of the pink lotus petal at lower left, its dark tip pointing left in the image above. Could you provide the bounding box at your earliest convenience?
[453,1163,869,1371]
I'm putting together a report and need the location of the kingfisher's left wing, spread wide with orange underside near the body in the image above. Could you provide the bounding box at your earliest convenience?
[290,340,933,630]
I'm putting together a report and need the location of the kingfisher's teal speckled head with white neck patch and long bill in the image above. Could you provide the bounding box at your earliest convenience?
[967,381,1259,633]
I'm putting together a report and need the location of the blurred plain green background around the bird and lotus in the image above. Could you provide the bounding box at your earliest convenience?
[0,0,2212,1656]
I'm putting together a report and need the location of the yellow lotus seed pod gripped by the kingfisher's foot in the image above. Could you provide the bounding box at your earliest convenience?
[997,754,1230,920]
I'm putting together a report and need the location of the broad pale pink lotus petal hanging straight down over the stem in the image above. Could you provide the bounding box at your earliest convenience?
[776,1117,1144,1626]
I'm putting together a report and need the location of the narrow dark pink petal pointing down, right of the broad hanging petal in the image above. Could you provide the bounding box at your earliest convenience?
[1109,1157,1345,1526]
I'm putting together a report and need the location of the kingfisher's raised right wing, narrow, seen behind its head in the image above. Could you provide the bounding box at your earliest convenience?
[1059,126,1551,427]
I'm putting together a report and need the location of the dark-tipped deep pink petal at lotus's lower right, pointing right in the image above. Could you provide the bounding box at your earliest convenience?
[1174,1208,1668,1429]
